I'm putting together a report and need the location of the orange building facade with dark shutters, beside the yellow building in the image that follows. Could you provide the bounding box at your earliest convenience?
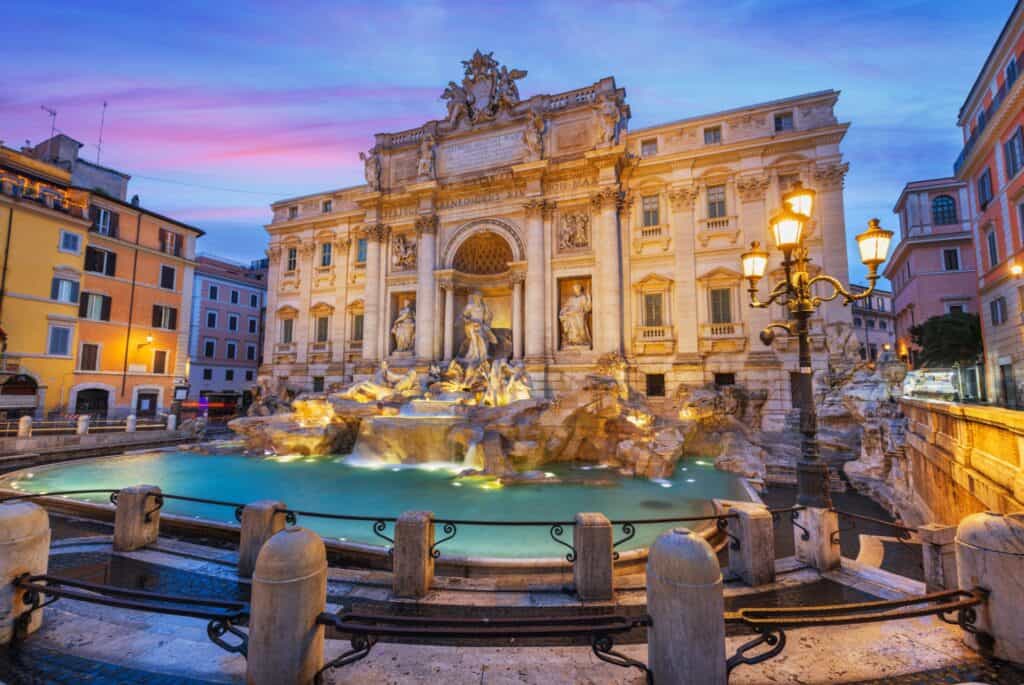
[68,195,203,416]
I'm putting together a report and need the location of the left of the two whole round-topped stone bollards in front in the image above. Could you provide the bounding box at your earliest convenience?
[246,526,327,685]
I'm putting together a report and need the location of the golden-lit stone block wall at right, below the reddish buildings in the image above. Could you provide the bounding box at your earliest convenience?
[901,399,1024,523]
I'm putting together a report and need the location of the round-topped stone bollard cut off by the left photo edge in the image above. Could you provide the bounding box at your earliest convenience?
[0,502,50,645]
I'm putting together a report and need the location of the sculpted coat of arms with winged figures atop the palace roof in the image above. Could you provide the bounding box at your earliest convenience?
[441,50,526,127]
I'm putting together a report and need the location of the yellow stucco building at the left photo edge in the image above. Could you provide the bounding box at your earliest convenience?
[0,146,90,418]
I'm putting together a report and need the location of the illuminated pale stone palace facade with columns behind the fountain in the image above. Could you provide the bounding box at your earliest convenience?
[261,52,850,429]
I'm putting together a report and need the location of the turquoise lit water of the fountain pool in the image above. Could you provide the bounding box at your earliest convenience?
[0,452,748,557]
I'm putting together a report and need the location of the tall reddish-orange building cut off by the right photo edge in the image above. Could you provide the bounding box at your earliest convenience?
[953,3,1024,408]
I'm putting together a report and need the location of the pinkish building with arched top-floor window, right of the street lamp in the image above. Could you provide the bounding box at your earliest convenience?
[883,177,979,367]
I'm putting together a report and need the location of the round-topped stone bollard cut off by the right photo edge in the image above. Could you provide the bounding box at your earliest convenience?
[956,512,1024,663]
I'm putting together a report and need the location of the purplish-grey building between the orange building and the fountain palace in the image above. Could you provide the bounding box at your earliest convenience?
[188,255,266,414]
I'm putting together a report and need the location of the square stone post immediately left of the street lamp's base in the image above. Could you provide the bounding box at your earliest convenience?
[716,500,775,587]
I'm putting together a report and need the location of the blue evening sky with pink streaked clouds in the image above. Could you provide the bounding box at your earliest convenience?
[0,0,1014,279]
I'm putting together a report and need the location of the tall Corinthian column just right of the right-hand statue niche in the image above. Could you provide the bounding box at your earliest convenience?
[591,188,623,354]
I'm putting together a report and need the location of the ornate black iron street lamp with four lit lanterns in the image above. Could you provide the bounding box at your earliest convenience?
[740,183,893,509]
